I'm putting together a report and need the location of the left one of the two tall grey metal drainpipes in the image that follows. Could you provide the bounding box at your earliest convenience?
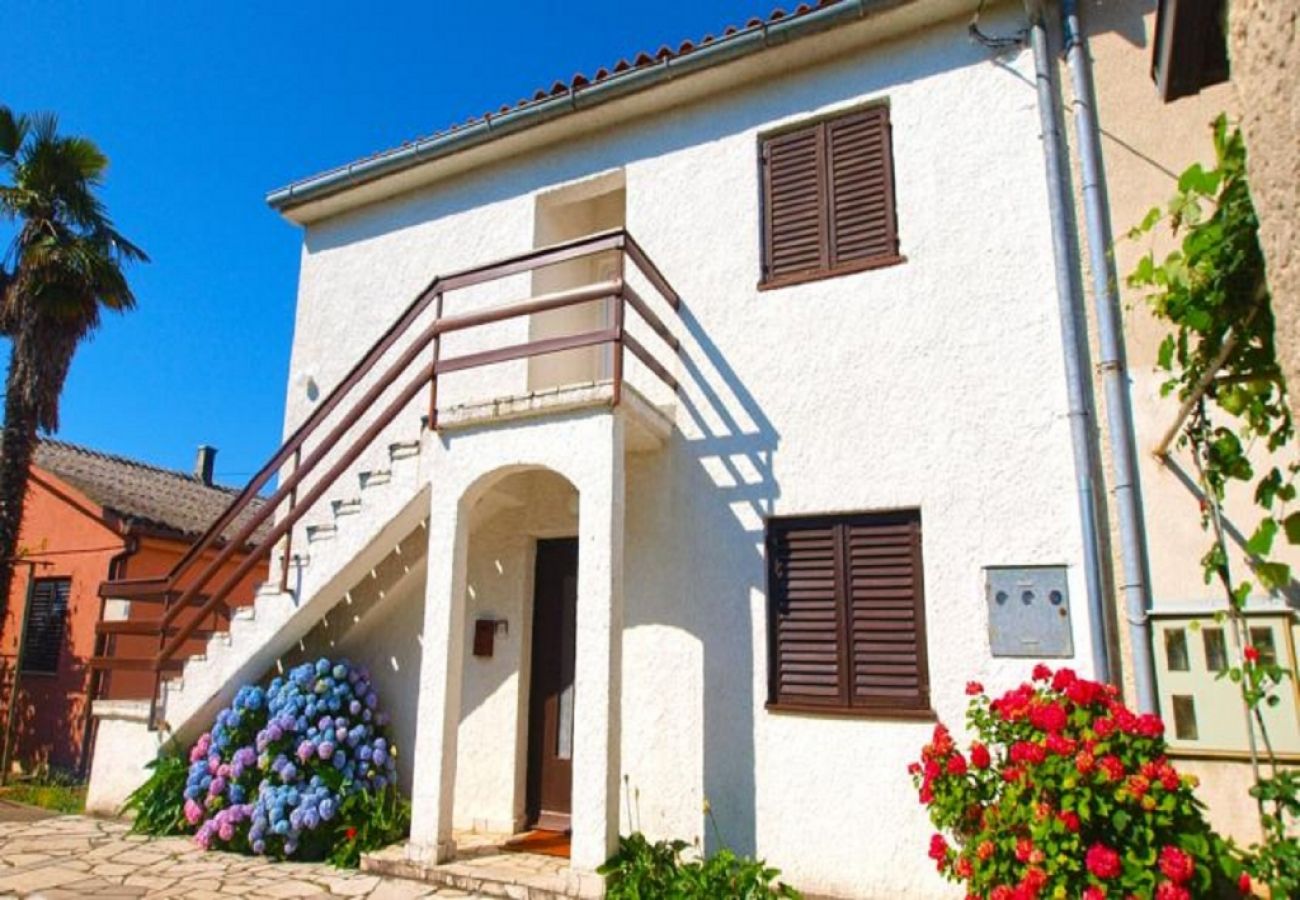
[1024,0,1115,680]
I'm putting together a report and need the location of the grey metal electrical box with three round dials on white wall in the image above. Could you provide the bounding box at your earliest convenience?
[984,566,1074,657]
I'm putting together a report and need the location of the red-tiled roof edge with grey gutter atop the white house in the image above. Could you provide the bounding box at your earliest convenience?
[267,0,910,211]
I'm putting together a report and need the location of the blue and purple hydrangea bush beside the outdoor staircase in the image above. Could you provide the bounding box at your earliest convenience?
[172,658,408,865]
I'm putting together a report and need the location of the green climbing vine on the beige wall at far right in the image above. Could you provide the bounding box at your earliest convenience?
[1128,116,1300,897]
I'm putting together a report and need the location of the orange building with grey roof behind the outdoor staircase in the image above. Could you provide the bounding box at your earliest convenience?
[0,440,267,775]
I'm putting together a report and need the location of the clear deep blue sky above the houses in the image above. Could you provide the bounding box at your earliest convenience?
[0,0,771,483]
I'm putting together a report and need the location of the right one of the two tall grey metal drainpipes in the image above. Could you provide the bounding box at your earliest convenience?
[1061,0,1158,713]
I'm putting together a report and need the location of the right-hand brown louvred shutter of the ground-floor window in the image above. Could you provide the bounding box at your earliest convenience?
[845,512,930,709]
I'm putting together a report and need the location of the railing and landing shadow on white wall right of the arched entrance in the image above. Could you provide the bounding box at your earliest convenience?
[625,295,779,853]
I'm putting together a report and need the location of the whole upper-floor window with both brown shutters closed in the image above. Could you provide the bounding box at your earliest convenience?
[759,104,902,287]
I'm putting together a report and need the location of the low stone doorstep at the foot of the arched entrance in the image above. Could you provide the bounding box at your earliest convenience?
[361,832,605,900]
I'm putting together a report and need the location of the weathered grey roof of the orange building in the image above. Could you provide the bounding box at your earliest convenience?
[33,438,269,538]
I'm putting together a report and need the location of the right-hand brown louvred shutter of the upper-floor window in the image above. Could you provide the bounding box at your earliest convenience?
[826,105,898,268]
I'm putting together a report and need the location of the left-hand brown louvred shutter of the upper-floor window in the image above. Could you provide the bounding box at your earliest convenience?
[763,125,828,280]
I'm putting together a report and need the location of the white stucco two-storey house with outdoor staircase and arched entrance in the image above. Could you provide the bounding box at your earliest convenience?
[81,0,1227,897]
